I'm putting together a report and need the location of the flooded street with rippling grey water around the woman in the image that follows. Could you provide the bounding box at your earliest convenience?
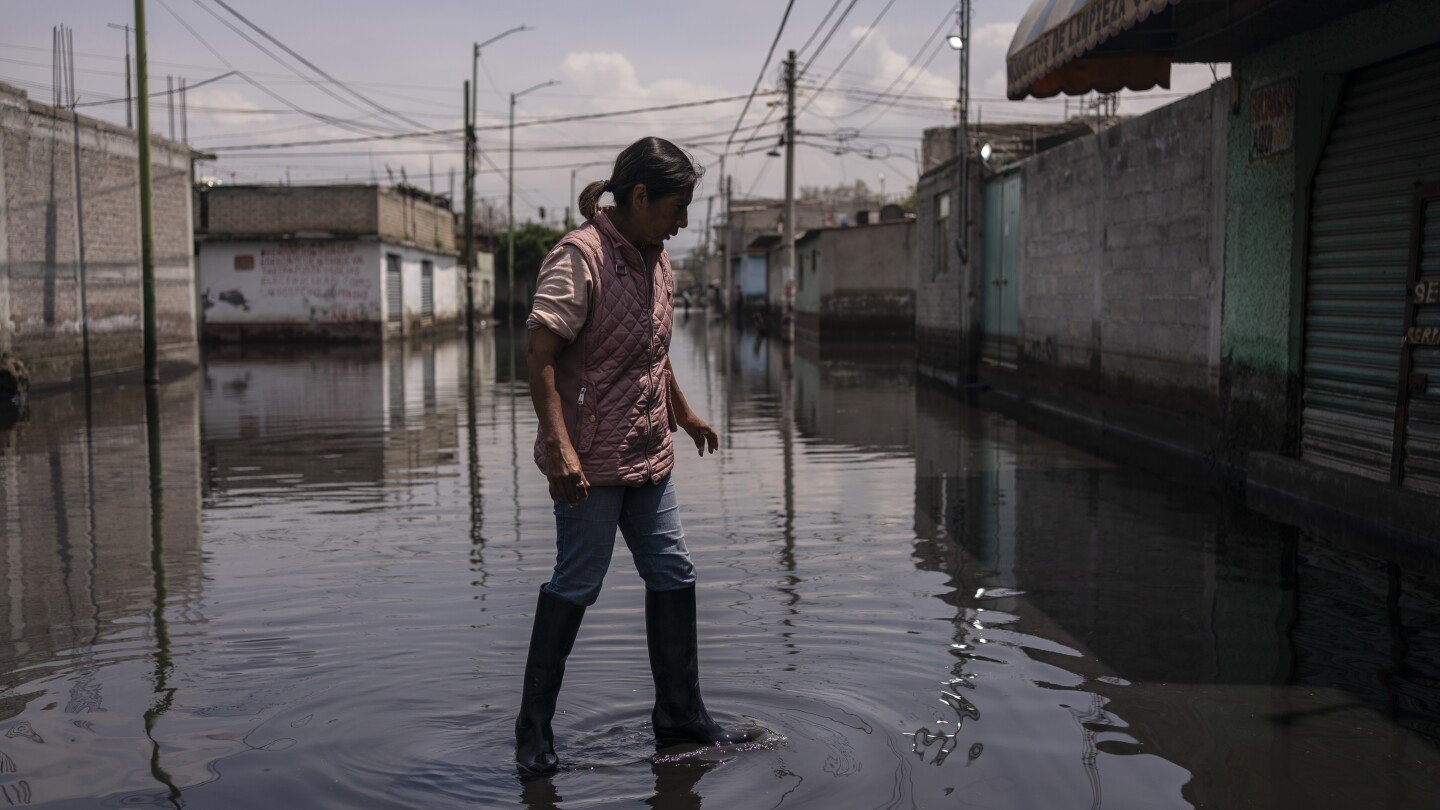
[0,316,1440,809]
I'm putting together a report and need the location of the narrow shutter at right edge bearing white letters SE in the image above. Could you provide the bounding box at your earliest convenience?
[1400,197,1440,494]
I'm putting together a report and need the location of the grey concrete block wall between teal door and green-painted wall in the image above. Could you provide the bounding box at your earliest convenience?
[1017,89,1228,418]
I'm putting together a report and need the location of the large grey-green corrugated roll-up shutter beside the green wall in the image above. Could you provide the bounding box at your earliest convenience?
[1300,48,1440,481]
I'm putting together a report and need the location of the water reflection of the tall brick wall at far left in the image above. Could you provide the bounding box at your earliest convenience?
[0,375,203,714]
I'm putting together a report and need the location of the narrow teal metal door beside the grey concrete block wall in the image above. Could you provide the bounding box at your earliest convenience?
[981,174,1020,365]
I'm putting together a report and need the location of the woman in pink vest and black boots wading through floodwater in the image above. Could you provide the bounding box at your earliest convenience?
[516,138,760,775]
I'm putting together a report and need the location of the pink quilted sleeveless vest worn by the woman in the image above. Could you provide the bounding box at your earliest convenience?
[536,210,675,487]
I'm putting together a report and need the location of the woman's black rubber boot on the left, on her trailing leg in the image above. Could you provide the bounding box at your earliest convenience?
[516,589,585,777]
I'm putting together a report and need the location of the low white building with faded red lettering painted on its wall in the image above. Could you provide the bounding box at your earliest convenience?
[196,186,460,340]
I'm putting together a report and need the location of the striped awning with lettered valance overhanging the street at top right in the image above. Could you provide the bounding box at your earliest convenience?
[1005,0,1181,101]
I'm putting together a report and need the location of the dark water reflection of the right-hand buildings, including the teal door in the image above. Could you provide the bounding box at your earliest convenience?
[914,386,1440,807]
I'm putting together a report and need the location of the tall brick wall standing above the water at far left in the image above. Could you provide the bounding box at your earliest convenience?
[0,84,196,386]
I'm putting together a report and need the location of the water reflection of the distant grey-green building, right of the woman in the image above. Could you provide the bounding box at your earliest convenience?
[792,344,914,453]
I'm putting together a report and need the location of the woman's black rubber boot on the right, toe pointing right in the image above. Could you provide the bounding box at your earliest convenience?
[645,585,760,747]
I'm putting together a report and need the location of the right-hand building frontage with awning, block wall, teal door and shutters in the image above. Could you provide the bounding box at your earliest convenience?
[961,0,1440,540]
